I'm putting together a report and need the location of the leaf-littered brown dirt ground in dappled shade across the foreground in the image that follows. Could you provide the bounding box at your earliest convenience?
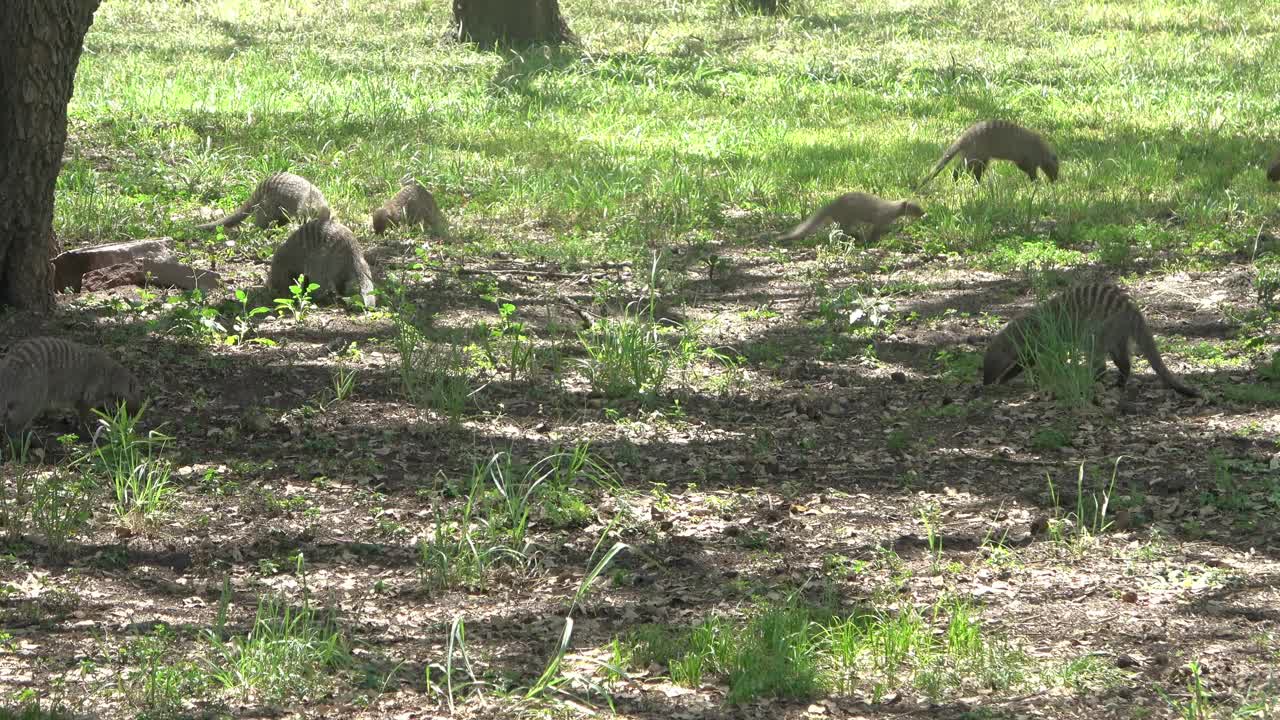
[0,233,1280,719]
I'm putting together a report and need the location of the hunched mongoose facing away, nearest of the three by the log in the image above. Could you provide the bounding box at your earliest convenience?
[270,218,375,307]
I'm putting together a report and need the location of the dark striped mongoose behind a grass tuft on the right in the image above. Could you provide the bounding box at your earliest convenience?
[982,283,1201,397]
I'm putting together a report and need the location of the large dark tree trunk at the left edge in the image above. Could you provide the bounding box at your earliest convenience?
[0,0,100,311]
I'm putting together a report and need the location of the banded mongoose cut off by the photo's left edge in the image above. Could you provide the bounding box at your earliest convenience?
[0,337,143,436]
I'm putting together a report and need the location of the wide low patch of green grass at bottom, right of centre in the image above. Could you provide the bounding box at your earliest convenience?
[627,591,1032,703]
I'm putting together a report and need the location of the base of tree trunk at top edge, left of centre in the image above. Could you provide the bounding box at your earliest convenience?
[453,0,573,49]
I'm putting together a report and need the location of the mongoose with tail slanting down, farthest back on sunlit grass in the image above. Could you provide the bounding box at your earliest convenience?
[915,120,1057,190]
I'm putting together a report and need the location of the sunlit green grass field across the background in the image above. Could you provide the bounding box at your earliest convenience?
[64,0,1280,265]
